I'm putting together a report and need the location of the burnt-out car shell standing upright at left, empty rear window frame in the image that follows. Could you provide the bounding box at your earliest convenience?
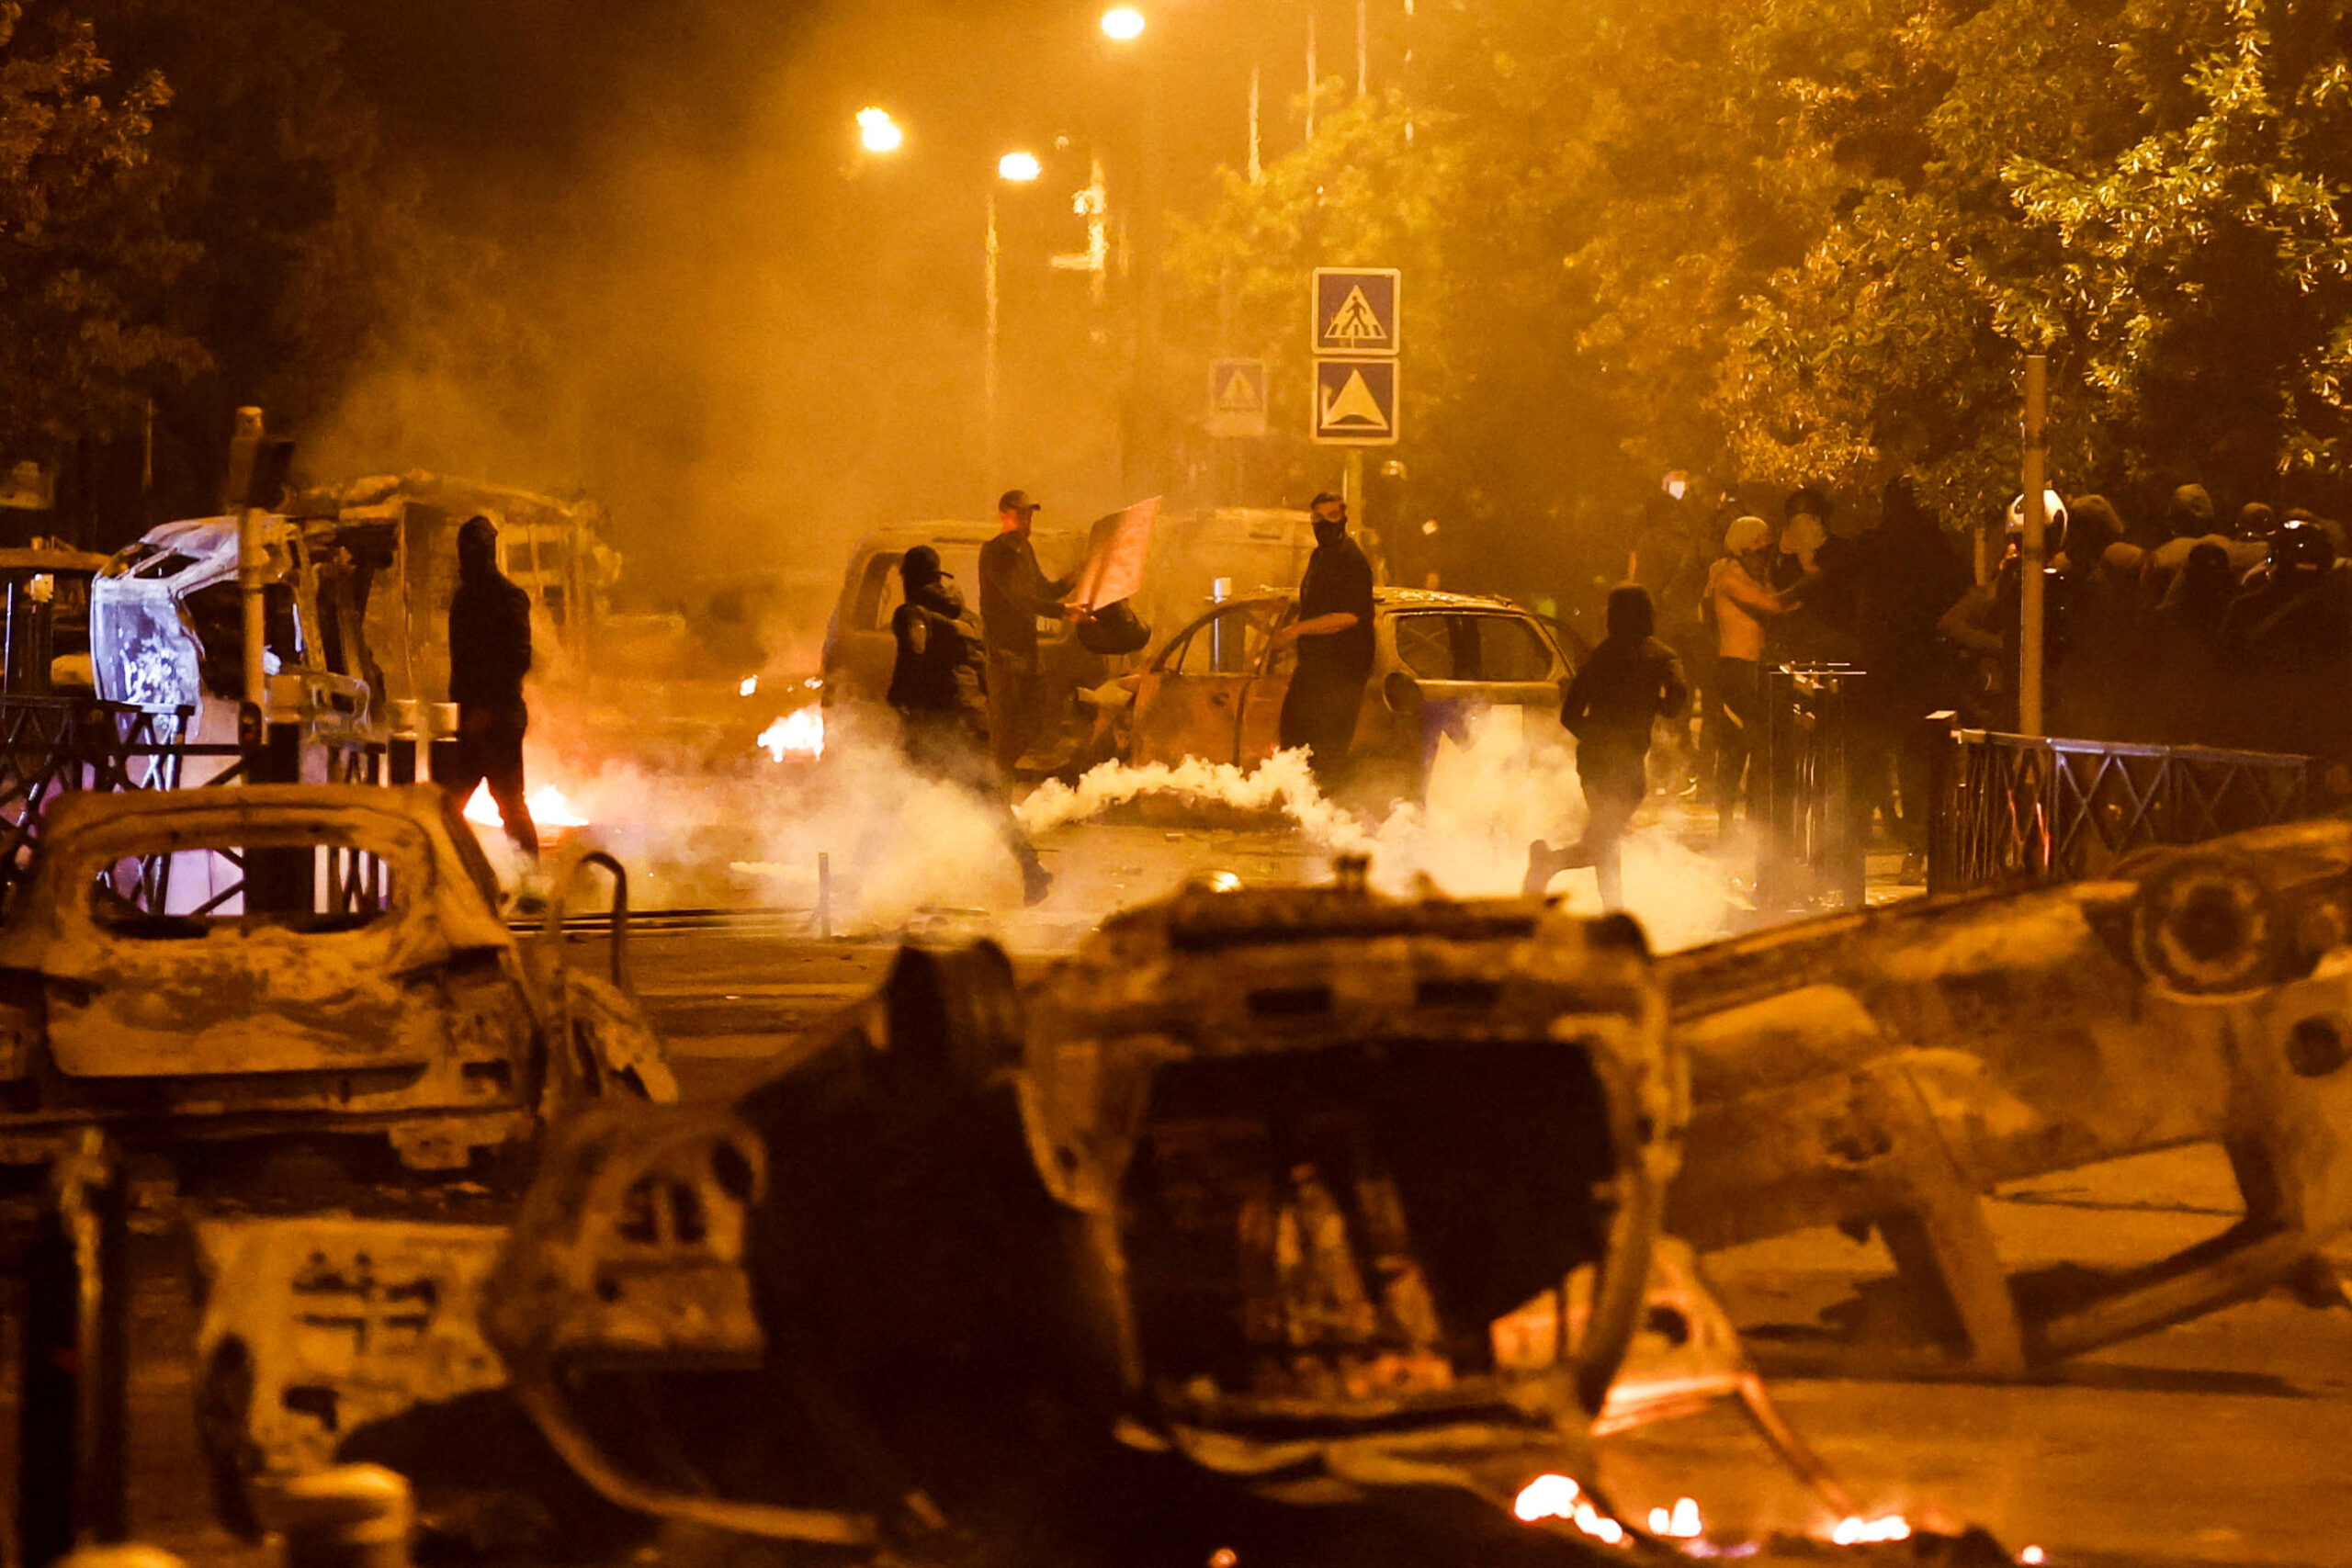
[0,785,677,1168]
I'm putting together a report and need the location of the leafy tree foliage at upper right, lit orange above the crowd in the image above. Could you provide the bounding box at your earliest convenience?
[1173,0,2352,552]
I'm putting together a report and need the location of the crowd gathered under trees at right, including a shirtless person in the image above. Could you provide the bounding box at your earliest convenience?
[1637,479,2352,869]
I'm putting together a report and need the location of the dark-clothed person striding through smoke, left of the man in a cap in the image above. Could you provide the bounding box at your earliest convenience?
[887,546,1054,903]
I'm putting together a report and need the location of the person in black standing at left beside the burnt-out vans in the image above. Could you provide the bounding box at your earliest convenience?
[440,517,538,858]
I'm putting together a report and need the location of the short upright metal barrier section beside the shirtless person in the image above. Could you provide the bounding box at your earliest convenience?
[1747,665,1870,909]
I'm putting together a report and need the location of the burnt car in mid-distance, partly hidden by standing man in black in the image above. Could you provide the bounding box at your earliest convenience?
[1126,588,1574,790]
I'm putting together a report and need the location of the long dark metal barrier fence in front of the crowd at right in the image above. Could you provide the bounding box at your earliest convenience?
[1927,715,2319,894]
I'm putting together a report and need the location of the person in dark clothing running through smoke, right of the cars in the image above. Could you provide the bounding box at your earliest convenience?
[1524,583,1691,909]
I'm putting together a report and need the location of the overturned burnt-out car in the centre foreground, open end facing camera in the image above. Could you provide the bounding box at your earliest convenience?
[482,865,1684,1561]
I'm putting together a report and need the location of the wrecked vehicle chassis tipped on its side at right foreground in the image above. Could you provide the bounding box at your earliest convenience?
[1660,818,2352,1378]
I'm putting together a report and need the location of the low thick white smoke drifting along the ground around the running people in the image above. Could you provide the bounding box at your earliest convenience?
[482,696,1734,947]
